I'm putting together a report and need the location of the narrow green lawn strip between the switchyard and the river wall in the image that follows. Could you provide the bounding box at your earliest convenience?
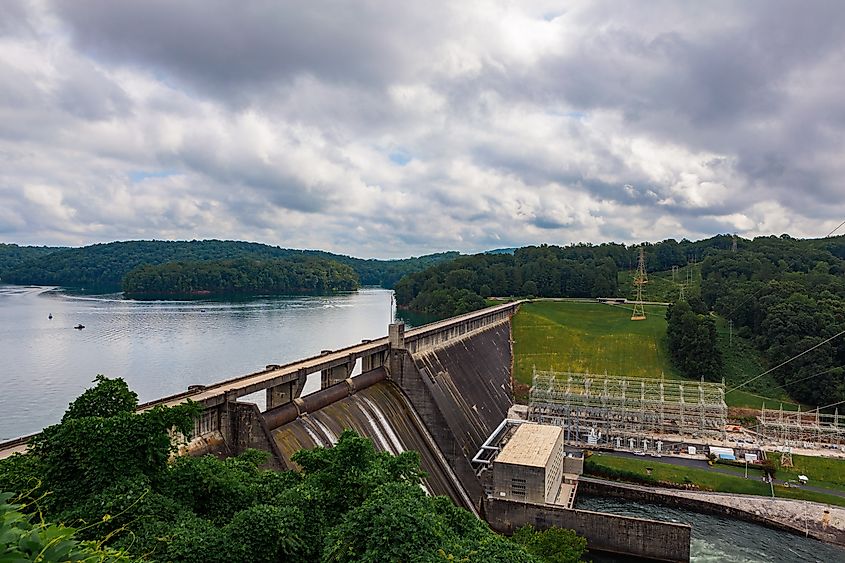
[589,454,845,506]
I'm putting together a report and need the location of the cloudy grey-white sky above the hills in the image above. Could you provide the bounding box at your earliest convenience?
[0,0,845,257]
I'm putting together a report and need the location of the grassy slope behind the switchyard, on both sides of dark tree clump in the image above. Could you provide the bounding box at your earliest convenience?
[513,301,797,410]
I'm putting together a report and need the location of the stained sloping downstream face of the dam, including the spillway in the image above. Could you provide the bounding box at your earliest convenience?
[265,318,513,510]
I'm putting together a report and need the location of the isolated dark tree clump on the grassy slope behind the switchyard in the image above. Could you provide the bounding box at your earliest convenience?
[666,301,722,381]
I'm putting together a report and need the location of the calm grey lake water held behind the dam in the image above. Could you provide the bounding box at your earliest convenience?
[0,285,408,440]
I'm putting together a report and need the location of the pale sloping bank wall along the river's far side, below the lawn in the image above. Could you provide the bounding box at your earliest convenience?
[578,476,845,547]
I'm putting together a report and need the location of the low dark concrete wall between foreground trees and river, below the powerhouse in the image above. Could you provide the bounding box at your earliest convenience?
[483,497,692,561]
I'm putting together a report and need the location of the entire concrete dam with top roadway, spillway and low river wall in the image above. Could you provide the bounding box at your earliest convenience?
[0,302,690,561]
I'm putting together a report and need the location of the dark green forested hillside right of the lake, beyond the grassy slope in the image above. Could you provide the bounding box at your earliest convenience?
[396,235,845,405]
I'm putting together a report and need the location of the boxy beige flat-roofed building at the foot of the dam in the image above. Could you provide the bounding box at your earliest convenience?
[491,424,564,504]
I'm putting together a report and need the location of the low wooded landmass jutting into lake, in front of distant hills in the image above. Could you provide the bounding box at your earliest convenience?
[123,257,358,299]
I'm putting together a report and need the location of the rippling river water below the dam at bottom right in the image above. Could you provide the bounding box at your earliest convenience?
[575,496,845,563]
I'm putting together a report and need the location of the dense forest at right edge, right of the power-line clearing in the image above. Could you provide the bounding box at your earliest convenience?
[701,235,845,406]
